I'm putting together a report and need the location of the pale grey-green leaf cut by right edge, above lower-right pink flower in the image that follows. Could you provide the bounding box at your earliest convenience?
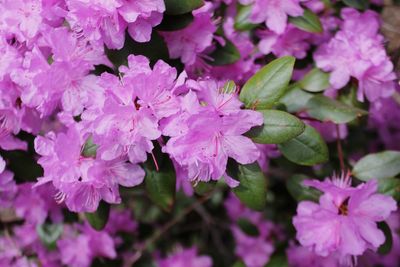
[352,151,400,181]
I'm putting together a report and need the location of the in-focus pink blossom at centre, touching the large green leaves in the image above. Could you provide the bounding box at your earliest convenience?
[163,80,263,185]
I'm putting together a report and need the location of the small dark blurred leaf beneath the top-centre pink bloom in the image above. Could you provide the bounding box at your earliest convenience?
[207,39,240,66]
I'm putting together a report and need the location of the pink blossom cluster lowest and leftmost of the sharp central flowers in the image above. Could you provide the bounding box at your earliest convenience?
[35,126,144,212]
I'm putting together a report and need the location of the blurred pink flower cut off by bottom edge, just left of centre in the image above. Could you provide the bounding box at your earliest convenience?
[157,248,212,267]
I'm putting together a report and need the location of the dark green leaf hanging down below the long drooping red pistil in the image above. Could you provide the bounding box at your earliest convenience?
[144,169,176,212]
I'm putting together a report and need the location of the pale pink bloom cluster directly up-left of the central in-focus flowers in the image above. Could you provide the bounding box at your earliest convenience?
[19,28,108,116]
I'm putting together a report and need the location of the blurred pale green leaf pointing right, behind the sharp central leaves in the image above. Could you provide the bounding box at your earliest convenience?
[307,95,368,124]
